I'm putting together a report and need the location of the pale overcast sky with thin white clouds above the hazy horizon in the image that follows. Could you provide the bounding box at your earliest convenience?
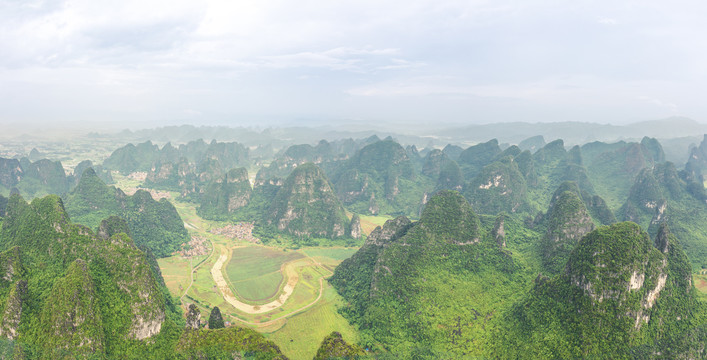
[0,0,707,127]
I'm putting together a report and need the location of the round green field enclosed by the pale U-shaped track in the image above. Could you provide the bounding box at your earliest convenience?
[226,246,304,303]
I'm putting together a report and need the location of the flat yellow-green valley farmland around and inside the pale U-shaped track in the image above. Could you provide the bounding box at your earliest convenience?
[147,191,362,359]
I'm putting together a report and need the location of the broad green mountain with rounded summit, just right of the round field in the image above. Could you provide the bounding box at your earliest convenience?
[330,191,520,358]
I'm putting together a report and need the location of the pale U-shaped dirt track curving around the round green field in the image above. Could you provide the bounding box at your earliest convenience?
[211,249,299,314]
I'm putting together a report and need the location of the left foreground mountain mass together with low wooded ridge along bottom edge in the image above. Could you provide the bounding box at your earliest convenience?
[0,194,285,359]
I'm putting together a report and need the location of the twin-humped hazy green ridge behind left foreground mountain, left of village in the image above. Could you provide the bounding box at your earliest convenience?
[64,168,188,257]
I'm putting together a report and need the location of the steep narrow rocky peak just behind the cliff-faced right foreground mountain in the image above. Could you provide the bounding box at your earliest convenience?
[542,191,594,273]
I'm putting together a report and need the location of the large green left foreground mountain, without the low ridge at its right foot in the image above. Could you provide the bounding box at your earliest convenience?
[0,195,175,358]
